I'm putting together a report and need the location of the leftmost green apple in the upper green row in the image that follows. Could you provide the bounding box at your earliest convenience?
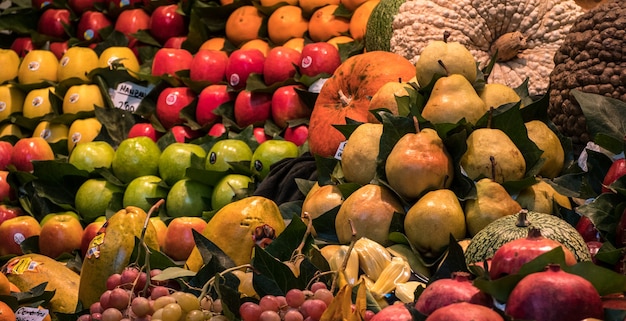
[68,141,115,172]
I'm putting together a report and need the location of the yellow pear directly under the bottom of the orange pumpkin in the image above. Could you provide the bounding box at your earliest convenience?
[341,123,383,185]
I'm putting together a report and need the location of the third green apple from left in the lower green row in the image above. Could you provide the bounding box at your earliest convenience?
[165,178,213,217]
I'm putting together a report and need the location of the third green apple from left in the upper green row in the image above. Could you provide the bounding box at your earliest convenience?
[159,143,207,186]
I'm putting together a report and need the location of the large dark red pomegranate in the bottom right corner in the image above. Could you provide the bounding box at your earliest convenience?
[504,264,604,321]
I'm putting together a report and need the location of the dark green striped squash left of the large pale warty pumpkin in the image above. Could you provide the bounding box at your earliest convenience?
[364,0,406,51]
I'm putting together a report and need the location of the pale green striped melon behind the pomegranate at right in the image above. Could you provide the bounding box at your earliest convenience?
[465,211,591,264]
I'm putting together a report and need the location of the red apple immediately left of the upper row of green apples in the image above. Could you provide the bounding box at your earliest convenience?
[11,136,54,172]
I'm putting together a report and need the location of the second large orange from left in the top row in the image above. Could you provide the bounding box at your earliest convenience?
[267,5,309,45]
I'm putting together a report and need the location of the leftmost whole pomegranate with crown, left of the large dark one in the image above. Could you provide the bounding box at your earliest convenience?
[415,272,493,315]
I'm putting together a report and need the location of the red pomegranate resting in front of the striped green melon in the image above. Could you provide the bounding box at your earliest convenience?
[489,227,576,280]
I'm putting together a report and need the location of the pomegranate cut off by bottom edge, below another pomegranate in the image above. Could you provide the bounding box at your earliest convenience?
[426,302,504,321]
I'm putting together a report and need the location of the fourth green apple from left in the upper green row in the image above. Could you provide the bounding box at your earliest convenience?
[204,138,252,174]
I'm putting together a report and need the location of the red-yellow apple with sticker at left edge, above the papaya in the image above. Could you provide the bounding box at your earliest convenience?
[0,215,41,256]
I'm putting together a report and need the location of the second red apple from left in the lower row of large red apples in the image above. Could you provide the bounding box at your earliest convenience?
[196,84,237,127]
